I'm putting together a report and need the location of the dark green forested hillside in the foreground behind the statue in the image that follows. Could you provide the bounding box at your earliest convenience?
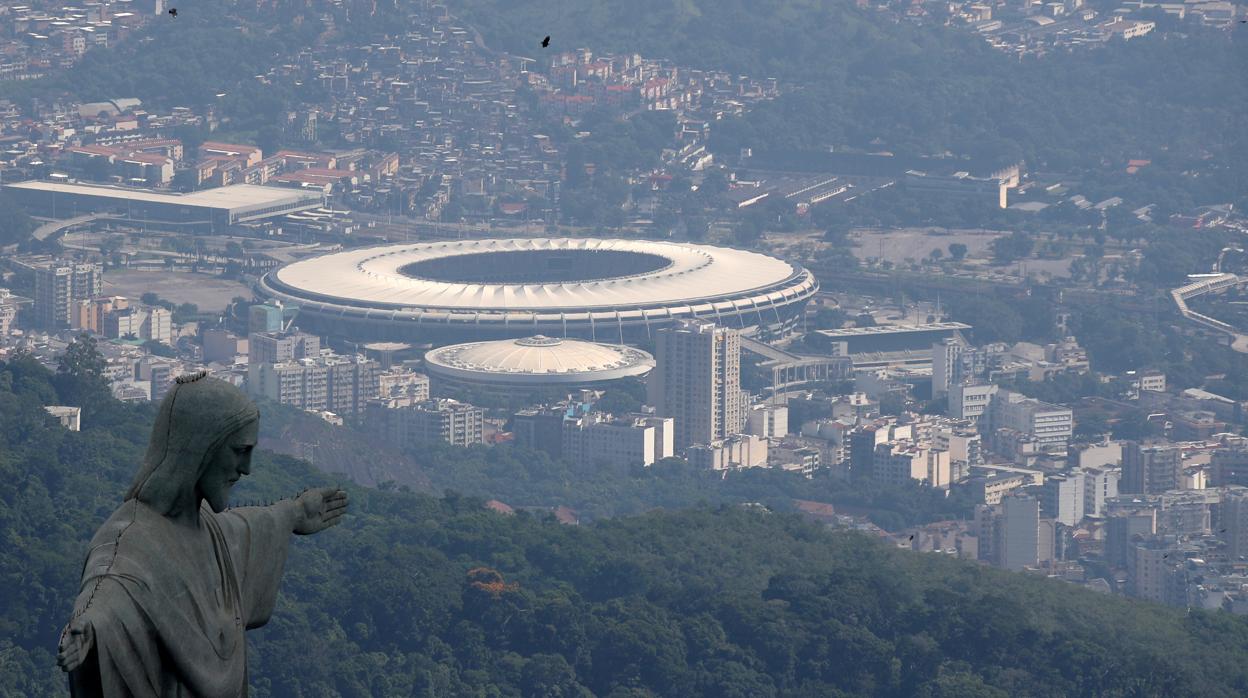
[0,360,1248,697]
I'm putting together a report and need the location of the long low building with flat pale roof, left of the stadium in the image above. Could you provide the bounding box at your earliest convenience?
[4,181,324,232]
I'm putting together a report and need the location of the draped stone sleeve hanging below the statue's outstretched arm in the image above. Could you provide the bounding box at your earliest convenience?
[213,504,291,629]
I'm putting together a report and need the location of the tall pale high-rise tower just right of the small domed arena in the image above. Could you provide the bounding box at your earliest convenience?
[648,321,745,450]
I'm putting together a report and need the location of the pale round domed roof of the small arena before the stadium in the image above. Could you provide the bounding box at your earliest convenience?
[424,335,654,385]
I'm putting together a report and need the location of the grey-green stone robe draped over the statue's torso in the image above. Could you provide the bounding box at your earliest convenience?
[70,499,291,698]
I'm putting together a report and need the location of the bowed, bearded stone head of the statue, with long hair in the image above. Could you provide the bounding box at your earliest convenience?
[126,373,260,514]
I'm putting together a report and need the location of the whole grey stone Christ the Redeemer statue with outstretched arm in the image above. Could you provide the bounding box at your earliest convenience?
[57,373,347,698]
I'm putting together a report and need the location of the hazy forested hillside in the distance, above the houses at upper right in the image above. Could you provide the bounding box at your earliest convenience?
[464,0,1248,177]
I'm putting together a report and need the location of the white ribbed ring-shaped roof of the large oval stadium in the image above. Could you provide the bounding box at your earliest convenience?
[273,238,804,311]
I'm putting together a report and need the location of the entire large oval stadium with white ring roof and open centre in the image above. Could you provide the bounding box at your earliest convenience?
[258,238,819,343]
